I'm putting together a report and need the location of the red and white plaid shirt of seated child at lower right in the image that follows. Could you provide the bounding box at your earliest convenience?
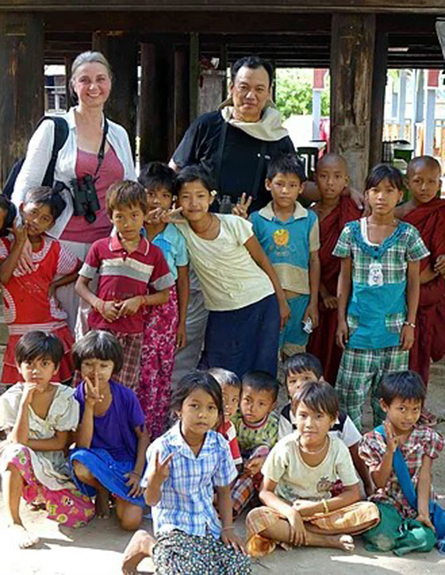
[359,425,443,518]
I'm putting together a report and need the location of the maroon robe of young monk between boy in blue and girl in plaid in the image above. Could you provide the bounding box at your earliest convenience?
[307,196,361,385]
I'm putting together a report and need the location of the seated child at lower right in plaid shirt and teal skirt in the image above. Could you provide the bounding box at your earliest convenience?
[359,371,443,555]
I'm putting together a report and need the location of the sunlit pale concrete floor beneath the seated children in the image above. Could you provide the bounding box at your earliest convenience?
[0,364,445,575]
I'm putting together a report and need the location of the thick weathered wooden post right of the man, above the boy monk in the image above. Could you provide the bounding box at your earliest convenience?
[331,14,376,189]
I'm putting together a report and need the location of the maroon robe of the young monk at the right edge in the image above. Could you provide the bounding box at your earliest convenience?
[404,198,445,385]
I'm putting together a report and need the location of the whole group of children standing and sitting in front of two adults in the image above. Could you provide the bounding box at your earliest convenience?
[0,148,445,574]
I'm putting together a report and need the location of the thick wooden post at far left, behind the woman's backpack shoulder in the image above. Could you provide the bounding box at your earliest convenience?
[0,12,44,184]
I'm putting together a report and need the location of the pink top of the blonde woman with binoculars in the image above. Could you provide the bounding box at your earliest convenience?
[60,147,124,244]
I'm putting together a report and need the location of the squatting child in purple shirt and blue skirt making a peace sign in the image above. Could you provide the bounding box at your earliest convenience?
[70,331,149,531]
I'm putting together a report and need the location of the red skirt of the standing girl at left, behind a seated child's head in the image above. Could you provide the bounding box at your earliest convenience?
[2,324,74,385]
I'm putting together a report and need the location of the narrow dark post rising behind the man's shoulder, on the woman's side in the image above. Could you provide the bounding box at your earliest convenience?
[173,47,190,149]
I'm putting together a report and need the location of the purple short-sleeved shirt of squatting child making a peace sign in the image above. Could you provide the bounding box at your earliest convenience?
[74,380,145,461]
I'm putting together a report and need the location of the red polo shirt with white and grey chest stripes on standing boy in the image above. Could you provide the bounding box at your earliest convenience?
[79,234,174,333]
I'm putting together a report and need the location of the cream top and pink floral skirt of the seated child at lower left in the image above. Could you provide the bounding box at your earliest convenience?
[0,383,94,527]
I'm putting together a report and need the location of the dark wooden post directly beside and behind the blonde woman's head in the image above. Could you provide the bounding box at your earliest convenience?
[93,31,139,155]
